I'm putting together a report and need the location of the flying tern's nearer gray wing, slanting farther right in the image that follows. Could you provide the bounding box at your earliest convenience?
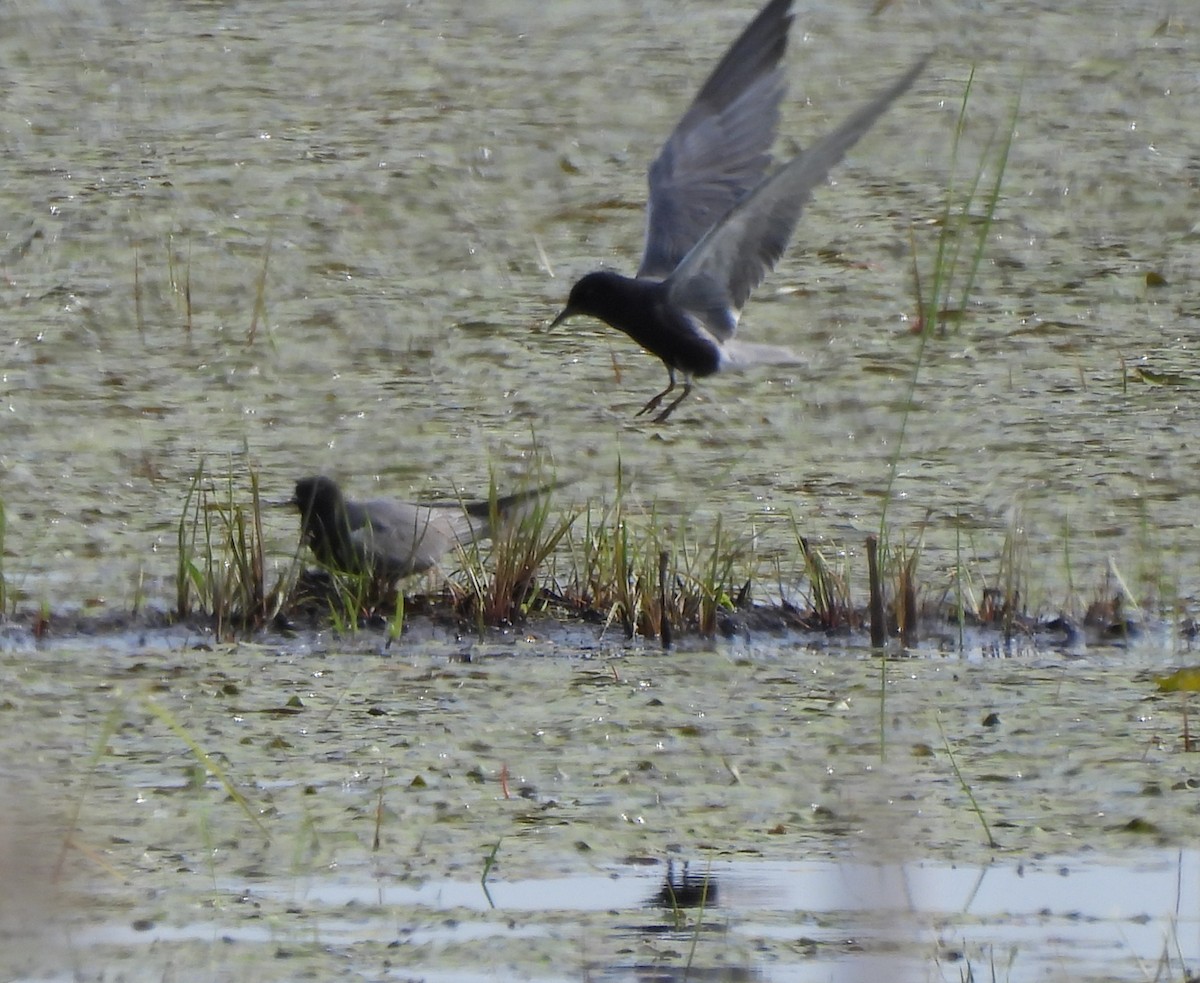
[667,54,930,340]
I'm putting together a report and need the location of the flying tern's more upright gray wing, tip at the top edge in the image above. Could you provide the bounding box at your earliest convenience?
[637,0,792,280]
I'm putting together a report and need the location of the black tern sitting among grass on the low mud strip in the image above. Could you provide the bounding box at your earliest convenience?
[292,475,556,581]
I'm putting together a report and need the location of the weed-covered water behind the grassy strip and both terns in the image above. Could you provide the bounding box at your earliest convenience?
[0,0,1200,610]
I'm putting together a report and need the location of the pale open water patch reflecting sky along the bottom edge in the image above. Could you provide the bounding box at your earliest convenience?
[96,850,1200,981]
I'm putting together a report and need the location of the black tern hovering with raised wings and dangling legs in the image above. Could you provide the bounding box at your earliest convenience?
[551,0,930,424]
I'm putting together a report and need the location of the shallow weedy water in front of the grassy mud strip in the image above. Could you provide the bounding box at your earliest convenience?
[0,636,1200,981]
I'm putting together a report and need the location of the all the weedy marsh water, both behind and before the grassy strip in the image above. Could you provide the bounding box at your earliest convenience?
[0,0,1200,979]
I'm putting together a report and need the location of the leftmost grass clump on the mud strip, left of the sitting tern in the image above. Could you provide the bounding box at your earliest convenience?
[175,461,287,634]
